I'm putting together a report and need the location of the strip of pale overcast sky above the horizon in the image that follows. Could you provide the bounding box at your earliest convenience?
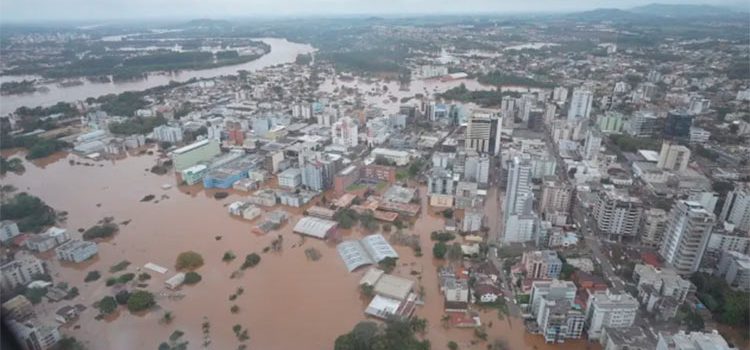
[0,0,742,22]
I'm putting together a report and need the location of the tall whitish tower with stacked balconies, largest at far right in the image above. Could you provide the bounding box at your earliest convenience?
[659,200,716,275]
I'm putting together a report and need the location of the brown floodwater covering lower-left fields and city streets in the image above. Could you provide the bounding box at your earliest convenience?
[2,153,600,350]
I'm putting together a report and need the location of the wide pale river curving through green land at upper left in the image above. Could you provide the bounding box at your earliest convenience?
[0,38,314,115]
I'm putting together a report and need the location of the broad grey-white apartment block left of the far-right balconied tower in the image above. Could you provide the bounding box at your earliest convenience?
[593,188,643,240]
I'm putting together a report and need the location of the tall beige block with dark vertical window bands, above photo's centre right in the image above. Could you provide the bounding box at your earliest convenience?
[465,111,503,155]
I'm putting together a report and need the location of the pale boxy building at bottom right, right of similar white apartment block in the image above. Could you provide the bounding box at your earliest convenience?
[586,290,638,339]
